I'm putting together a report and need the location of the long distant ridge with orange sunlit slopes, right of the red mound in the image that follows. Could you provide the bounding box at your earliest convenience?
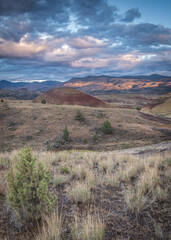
[61,74,171,94]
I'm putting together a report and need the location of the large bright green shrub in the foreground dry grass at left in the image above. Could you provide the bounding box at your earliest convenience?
[7,148,56,221]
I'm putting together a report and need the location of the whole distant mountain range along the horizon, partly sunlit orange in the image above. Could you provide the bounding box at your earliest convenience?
[0,74,171,99]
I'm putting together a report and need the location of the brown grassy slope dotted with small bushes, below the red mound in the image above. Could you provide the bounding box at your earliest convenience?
[0,99,170,151]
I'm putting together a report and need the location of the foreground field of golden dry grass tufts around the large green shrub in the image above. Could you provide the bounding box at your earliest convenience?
[0,150,171,240]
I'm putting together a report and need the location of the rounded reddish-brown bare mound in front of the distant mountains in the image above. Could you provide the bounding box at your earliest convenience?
[34,87,107,107]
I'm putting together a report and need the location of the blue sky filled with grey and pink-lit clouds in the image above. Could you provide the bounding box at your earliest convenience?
[0,0,171,82]
